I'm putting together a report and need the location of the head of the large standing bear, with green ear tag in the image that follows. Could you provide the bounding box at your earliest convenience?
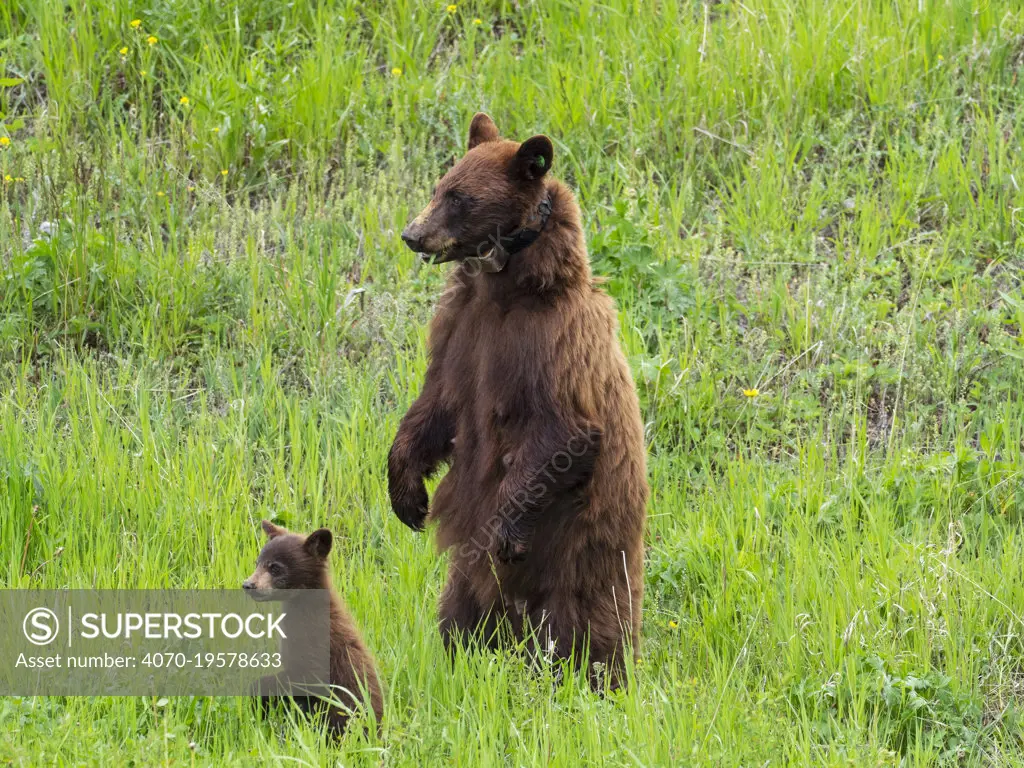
[401,113,554,263]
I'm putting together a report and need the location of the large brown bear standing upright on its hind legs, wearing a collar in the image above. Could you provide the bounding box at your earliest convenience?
[388,114,647,686]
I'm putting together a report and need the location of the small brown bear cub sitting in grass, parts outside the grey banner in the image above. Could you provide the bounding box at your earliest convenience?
[242,520,383,736]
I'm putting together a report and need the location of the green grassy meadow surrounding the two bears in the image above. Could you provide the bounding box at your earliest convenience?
[0,0,1024,766]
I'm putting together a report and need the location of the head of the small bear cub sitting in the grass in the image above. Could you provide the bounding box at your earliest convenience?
[242,520,333,600]
